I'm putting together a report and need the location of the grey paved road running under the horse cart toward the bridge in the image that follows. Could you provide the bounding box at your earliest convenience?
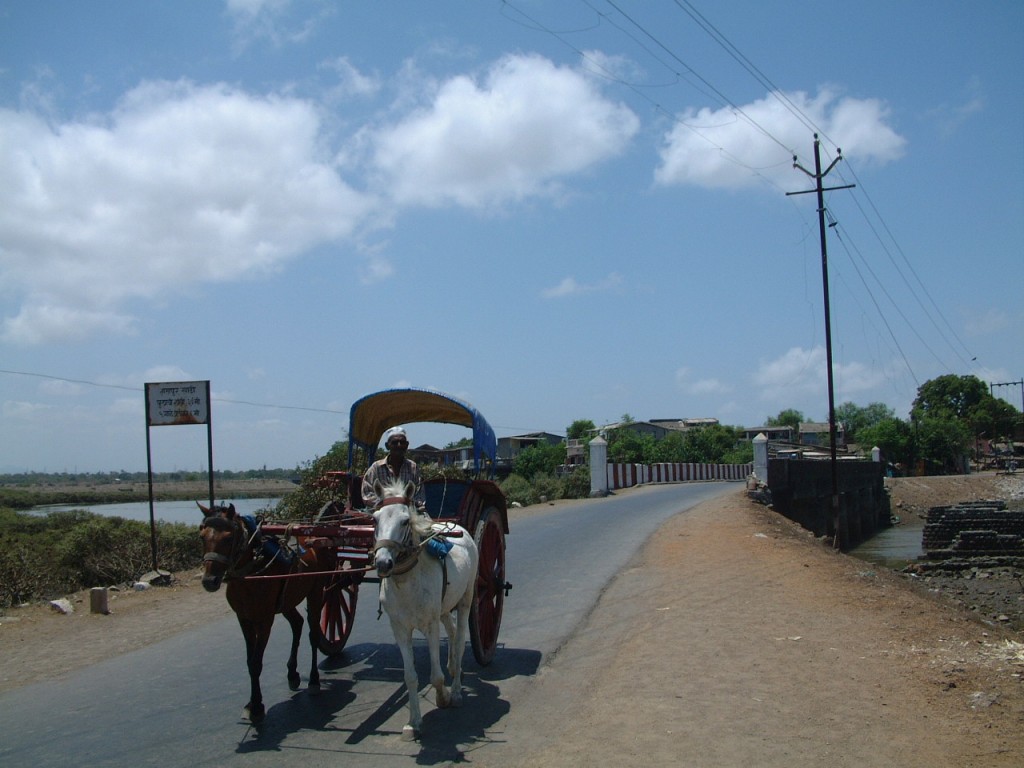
[0,483,735,768]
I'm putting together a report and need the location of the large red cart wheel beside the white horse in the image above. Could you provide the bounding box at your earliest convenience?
[469,507,506,667]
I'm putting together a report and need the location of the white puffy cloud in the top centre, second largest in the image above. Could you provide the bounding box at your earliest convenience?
[373,55,639,208]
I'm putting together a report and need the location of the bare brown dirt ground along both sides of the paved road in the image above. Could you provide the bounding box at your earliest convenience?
[0,475,1024,768]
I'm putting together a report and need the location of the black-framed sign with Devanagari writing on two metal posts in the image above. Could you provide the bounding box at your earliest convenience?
[145,381,213,572]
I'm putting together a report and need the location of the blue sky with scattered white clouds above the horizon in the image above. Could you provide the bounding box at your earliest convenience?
[0,0,1024,472]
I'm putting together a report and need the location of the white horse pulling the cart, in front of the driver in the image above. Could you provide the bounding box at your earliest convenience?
[374,482,479,741]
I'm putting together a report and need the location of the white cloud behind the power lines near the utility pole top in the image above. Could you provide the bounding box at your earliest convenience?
[654,88,906,188]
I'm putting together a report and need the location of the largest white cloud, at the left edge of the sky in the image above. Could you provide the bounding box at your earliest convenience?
[0,82,372,343]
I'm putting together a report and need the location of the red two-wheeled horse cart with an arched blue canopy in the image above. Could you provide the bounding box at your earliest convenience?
[250,389,511,667]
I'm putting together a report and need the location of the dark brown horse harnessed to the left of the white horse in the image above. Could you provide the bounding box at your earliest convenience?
[197,502,334,723]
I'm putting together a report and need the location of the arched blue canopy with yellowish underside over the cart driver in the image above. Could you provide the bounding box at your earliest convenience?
[348,389,498,474]
